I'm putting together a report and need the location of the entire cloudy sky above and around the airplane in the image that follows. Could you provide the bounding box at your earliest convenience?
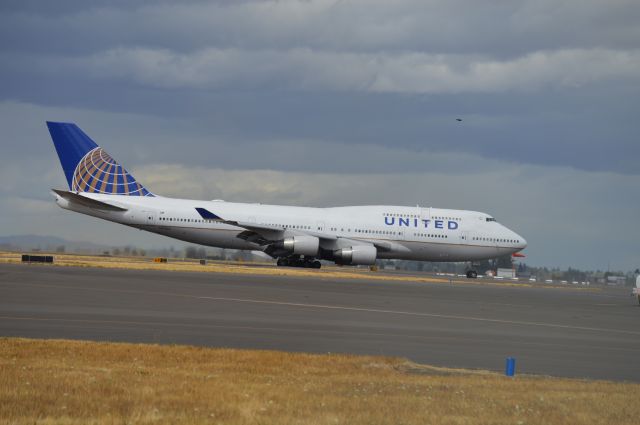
[0,0,640,270]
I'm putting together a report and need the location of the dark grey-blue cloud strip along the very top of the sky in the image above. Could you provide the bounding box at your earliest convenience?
[0,0,640,57]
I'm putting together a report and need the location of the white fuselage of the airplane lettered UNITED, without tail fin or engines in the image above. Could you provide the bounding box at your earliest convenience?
[56,193,526,261]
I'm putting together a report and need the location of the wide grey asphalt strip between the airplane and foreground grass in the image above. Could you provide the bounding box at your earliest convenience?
[0,264,640,382]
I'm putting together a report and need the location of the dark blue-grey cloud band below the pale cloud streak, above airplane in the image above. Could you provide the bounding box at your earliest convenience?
[0,60,640,174]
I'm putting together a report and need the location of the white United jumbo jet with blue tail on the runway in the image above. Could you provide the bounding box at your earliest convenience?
[47,121,527,278]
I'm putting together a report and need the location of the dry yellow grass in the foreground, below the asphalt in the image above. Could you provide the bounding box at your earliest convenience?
[0,338,640,425]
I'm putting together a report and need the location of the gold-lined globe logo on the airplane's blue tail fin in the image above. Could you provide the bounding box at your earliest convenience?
[71,147,153,196]
